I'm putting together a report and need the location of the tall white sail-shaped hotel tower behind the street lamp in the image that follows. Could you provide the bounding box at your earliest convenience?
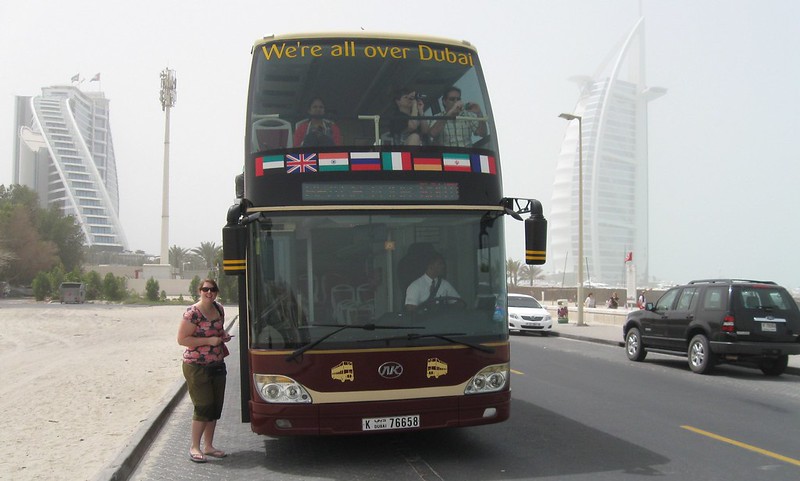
[548,18,666,286]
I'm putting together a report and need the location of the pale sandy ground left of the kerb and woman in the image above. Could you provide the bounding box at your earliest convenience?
[0,299,236,481]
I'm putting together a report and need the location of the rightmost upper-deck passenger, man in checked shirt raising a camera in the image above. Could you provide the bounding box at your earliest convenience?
[430,86,487,147]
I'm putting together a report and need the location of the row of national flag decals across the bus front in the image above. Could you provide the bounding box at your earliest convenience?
[255,152,497,176]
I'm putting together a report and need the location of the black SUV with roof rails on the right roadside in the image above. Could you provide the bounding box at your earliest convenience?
[623,279,800,376]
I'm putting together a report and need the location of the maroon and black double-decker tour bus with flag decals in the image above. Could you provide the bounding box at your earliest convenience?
[223,32,547,436]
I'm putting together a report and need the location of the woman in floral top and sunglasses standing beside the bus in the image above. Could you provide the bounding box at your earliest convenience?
[178,279,231,463]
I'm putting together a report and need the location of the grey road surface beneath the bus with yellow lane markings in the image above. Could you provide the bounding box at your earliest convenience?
[132,336,800,481]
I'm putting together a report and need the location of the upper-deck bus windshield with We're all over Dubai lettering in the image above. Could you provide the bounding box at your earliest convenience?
[247,37,496,154]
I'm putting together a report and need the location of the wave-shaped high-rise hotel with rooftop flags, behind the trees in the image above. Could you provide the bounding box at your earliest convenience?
[12,86,127,251]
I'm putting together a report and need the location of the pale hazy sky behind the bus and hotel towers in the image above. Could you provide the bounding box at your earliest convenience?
[0,0,800,287]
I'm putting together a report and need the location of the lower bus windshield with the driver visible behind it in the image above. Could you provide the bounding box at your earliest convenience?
[248,211,507,349]
